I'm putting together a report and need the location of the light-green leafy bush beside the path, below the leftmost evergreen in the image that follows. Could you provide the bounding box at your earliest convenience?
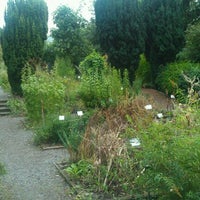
[22,68,65,122]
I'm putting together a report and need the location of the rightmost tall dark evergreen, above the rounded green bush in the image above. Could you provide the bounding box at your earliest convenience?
[143,0,185,81]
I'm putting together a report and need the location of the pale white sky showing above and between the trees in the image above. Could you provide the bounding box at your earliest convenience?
[0,0,93,29]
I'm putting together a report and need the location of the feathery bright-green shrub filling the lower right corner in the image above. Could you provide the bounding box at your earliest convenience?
[135,108,200,200]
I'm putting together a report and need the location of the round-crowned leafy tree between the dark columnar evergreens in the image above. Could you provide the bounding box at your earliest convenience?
[52,6,91,66]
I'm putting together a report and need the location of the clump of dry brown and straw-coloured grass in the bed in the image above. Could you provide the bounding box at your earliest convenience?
[79,96,153,162]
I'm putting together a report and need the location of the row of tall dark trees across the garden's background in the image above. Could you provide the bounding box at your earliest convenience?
[1,0,200,95]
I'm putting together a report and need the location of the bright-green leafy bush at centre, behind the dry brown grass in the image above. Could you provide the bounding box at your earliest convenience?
[79,53,129,108]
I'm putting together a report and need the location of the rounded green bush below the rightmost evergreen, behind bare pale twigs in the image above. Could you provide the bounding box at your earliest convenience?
[156,62,200,95]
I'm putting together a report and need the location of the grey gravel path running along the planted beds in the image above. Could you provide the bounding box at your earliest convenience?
[0,89,69,200]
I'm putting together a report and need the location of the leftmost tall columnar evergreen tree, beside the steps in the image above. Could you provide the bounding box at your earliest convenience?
[2,0,48,95]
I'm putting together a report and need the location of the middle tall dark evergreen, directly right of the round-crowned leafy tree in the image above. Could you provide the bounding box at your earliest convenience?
[95,0,144,79]
